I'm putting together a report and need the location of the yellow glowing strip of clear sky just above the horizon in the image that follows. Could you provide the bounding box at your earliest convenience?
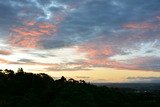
[16,68,160,83]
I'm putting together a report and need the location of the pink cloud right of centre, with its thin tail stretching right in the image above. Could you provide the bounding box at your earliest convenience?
[74,44,155,70]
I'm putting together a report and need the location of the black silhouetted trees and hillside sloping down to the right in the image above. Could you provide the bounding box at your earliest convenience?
[0,68,160,107]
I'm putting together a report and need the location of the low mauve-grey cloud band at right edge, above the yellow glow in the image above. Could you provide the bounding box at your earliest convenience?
[110,57,160,72]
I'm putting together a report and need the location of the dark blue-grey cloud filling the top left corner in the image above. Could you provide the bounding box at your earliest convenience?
[0,0,43,38]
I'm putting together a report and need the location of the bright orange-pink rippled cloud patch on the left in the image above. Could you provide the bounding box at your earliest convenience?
[8,21,57,48]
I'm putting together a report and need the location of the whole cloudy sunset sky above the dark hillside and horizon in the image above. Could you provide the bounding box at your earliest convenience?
[0,0,160,83]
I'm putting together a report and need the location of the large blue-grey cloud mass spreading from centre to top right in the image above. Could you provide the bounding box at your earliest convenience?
[43,0,160,48]
